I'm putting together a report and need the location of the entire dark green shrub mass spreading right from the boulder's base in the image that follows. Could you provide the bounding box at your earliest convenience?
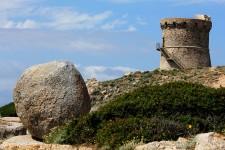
[45,82,225,149]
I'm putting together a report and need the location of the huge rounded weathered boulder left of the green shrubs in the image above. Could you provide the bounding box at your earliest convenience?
[14,61,91,139]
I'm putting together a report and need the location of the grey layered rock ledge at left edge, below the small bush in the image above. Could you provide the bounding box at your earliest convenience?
[0,117,26,139]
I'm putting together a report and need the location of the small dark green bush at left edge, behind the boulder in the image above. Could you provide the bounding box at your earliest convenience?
[0,103,17,117]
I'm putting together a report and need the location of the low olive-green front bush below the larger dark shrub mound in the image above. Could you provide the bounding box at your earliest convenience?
[96,117,188,149]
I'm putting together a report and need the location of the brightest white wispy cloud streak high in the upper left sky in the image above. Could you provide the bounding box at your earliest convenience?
[0,8,112,30]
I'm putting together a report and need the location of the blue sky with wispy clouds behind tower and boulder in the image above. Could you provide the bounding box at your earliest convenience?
[0,0,225,105]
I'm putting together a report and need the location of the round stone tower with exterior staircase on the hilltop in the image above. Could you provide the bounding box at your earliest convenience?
[157,15,212,70]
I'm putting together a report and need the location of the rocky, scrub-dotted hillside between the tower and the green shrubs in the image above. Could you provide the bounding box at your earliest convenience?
[86,67,225,111]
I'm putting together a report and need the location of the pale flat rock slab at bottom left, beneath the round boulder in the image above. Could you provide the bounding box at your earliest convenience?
[0,135,96,150]
